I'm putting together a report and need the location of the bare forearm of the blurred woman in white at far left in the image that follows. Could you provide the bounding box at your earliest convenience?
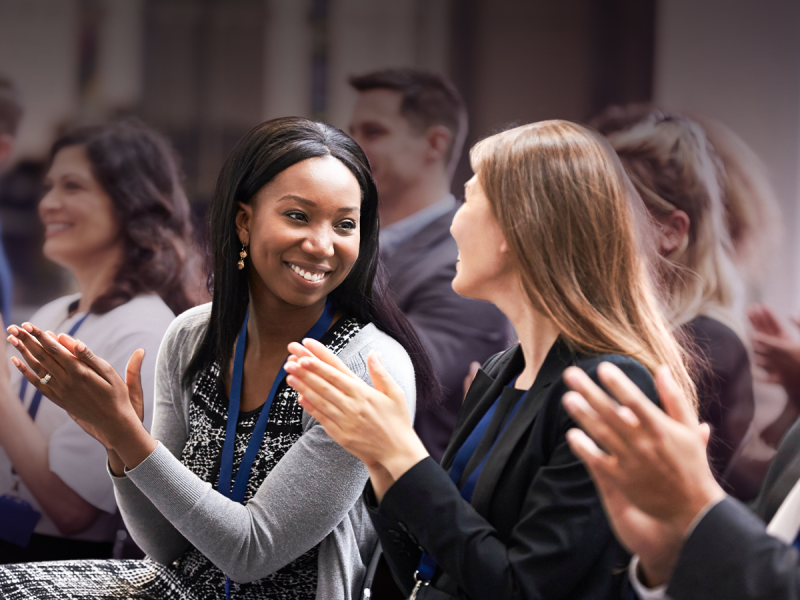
[0,397,100,535]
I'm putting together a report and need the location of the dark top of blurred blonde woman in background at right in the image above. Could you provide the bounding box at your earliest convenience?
[684,316,755,500]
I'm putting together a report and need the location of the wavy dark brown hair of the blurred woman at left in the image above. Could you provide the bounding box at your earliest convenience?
[50,119,197,314]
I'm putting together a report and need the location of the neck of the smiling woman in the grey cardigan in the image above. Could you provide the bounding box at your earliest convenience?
[247,292,325,358]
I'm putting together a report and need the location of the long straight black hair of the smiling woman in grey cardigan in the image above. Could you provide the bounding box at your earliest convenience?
[183,117,440,401]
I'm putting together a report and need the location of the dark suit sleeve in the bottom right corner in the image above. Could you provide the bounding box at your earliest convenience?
[667,497,800,600]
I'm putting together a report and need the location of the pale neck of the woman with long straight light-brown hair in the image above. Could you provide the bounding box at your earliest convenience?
[496,282,561,390]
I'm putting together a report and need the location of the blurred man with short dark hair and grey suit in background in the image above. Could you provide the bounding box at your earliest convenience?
[350,69,509,461]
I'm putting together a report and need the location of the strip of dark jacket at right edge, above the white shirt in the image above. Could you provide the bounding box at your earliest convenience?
[753,420,800,523]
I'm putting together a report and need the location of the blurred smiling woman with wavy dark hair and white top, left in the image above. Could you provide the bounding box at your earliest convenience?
[0,120,193,563]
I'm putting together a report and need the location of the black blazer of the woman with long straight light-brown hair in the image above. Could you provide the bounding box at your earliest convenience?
[365,341,656,600]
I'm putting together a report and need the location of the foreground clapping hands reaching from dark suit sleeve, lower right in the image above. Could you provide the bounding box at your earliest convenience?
[563,363,725,586]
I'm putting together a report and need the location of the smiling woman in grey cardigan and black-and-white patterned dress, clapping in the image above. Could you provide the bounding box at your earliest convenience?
[0,118,432,600]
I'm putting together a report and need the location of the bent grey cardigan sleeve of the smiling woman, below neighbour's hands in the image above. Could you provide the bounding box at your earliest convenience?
[128,426,374,582]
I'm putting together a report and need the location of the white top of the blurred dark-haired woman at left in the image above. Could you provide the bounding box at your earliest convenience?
[0,294,175,542]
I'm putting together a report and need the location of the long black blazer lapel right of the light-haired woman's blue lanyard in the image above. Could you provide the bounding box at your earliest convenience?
[471,340,575,515]
